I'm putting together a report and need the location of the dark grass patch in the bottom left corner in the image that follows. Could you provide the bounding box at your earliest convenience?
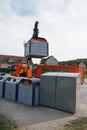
[0,114,16,130]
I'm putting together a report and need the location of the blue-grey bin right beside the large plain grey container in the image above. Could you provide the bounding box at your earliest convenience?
[18,78,40,106]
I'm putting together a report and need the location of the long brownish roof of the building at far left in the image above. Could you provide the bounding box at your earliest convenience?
[0,55,27,63]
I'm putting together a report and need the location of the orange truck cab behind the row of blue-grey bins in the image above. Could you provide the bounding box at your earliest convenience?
[11,63,32,78]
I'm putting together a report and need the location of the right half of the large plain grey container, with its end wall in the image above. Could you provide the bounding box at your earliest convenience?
[56,73,81,113]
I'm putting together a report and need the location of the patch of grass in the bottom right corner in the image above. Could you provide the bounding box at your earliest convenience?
[62,117,87,130]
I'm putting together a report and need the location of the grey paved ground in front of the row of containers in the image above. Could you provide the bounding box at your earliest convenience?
[0,80,87,130]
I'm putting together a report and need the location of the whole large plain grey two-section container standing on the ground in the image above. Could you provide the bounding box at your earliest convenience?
[40,73,80,113]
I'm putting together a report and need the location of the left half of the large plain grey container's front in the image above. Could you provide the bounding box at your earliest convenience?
[40,73,56,107]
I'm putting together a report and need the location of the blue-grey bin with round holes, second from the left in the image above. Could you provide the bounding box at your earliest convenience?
[4,76,18,101]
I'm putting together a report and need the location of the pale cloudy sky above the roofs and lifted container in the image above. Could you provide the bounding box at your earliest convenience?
[0,0,87,61]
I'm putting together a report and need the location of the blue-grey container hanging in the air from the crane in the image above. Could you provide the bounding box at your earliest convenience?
[24,40,49,58]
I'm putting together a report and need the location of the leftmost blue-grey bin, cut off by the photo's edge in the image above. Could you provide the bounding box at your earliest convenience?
[0,76,7,97]
